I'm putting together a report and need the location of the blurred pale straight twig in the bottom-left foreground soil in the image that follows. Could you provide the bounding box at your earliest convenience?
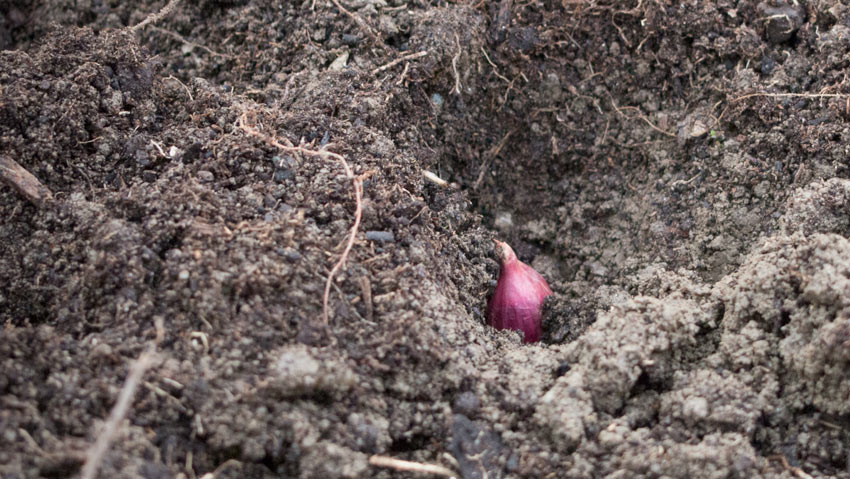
[80,346,155,479]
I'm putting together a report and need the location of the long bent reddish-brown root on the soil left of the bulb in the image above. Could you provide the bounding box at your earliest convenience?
[237,113,372,324]
